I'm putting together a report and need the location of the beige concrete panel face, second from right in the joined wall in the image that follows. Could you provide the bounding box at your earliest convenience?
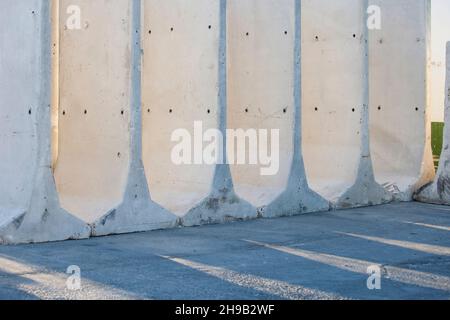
[302,0,365,202]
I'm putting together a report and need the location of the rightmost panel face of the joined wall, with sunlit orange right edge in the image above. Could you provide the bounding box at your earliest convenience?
[369,0,434,201]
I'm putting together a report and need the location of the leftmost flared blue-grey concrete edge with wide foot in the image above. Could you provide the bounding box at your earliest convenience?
[0,0,90,244]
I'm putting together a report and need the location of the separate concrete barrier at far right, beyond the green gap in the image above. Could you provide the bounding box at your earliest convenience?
[416,42,450,205]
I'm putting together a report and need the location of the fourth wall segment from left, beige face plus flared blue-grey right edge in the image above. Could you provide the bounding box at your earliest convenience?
[228,0,329,217]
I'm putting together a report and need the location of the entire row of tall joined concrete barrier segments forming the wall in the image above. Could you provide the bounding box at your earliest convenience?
[0,0,436,242]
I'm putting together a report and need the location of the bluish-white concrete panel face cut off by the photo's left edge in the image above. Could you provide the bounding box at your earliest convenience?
[0,0,42,225]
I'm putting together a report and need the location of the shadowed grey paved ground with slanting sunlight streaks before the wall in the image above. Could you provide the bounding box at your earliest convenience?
[0,203,450,299]
